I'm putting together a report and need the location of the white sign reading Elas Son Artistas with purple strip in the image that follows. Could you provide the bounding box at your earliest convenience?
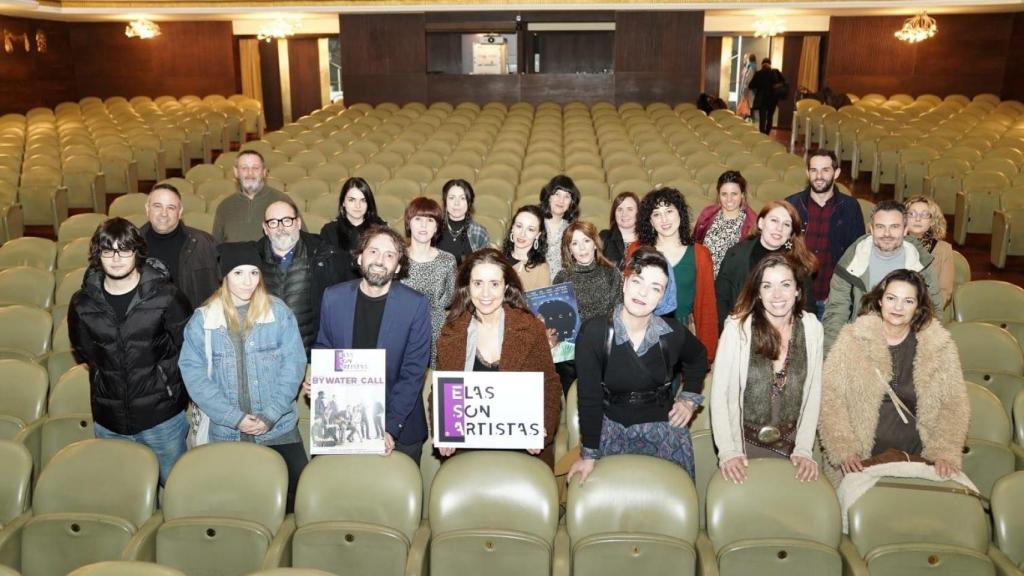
[431,372,544,450]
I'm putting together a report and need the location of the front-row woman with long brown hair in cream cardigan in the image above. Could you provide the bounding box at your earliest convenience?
[711,254,822,484]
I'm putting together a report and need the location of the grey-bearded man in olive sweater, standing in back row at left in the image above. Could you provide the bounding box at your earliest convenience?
[213,150,288,244]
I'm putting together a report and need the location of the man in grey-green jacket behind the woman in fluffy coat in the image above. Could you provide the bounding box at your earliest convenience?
[821,200,941,355]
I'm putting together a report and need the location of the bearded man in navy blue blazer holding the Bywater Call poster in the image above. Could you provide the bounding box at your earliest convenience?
[317,225,430,464]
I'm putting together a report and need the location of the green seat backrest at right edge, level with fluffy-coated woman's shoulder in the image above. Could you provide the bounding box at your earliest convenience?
[947,322,1024,375]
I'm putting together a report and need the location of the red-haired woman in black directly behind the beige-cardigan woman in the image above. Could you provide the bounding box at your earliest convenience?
[715,201,818,330]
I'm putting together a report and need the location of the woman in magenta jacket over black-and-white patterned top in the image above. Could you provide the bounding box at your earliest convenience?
[693,170,758,276]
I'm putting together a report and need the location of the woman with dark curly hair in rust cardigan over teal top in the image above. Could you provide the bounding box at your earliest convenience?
[630,188,718,363]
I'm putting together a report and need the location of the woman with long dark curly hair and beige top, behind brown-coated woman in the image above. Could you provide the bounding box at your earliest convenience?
[502,204,552,292]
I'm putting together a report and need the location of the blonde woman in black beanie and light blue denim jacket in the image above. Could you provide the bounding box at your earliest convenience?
[178,242,307,511]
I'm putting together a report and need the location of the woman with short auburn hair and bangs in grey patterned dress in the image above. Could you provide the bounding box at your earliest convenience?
[401,197,455,366]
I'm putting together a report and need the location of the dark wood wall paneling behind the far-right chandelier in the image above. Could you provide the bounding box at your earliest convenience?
[825,13,1015,96]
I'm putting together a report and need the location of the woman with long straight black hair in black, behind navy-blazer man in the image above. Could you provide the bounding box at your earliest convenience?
[321,177,385,282]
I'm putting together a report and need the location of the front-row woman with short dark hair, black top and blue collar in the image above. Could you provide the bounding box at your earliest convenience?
[568,247,708,482]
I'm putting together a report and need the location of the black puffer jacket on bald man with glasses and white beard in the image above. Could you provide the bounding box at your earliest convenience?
[256,232,343,356]
